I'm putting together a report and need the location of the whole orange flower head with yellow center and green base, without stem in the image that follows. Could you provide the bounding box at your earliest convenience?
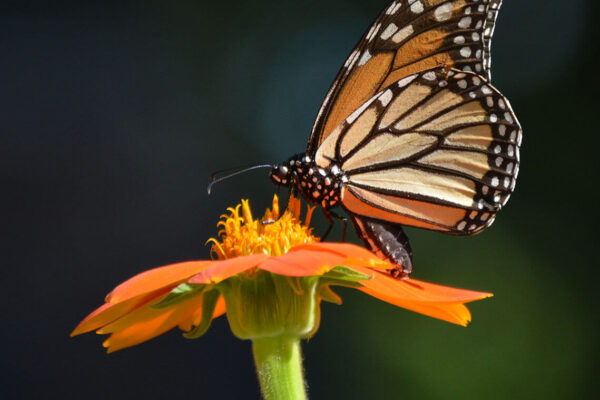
[71,196,491,353]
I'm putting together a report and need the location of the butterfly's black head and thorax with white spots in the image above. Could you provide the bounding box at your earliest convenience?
[270,154,348,209]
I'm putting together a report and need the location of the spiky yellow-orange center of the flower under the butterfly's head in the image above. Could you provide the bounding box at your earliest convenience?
[207,195,319,260]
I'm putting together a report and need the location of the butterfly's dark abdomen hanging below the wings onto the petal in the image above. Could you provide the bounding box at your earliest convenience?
[351,215,413,279]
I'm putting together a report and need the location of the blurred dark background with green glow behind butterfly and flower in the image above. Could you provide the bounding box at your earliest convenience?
[0,0,600,399]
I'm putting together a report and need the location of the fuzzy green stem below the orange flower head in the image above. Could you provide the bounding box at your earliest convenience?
[252,336,306,400]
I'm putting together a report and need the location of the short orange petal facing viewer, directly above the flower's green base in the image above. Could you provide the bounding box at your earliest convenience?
[258,248,346,276]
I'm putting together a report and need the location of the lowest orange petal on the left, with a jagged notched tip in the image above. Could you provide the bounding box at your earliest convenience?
[98,295,203,353]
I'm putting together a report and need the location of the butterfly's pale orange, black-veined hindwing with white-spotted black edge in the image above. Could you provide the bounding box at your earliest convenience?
[316,68,521,234]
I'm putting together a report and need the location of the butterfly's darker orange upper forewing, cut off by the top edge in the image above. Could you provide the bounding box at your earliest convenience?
[307,0,501,154]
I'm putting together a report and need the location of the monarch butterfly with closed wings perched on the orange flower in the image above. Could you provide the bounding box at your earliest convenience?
[270,0,522,278]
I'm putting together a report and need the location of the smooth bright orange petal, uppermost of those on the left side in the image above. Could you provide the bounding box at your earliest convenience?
[106,261,214,303]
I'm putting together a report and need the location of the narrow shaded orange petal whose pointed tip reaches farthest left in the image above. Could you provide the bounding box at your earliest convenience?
[71,286,172,336]
